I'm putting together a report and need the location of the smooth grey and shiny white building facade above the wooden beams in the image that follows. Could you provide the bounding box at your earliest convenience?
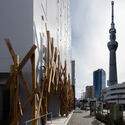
[0,0,71,76]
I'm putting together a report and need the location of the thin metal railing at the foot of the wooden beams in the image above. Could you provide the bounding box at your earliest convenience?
[25,112,52,125]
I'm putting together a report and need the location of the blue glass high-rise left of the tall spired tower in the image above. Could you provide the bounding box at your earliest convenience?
[93,69,106,98]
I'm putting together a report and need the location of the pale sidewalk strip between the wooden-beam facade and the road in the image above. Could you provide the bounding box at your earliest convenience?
[47,111,73,125]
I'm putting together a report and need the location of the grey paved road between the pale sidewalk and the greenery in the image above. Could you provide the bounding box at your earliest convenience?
[67,109,104,125]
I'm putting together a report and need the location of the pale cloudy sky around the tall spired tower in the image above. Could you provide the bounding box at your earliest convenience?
[71,0,125,98]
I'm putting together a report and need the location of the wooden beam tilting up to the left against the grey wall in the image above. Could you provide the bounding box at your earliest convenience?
[4,39,16,64]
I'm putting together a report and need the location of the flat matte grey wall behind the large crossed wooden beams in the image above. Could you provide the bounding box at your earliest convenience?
[0,0,33,72]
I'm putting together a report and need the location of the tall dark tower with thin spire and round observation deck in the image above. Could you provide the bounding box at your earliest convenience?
[107,1,118,86]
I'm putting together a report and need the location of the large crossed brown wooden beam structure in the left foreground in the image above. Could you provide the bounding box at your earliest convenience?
[5,39,41,125]
